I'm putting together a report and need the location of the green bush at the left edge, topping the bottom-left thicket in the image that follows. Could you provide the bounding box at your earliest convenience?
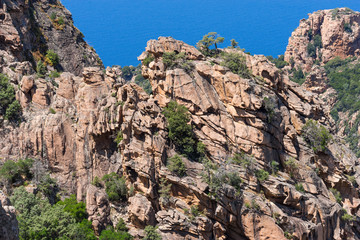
[0,158,34,184]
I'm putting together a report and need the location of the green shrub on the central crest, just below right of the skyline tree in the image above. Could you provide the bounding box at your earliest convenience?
[221,52,252,78]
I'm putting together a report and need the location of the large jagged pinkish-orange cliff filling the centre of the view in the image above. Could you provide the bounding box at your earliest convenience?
[0,1,360,239]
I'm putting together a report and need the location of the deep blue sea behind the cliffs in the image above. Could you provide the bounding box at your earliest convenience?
[61,0,360,66]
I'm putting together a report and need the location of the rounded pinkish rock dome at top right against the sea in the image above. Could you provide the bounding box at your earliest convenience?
[285,8,360,72]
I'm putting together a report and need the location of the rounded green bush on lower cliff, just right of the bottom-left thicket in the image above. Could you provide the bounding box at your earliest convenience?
[102,172,128,202]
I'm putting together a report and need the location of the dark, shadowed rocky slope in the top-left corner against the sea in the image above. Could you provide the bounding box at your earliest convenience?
[0,0,102,75]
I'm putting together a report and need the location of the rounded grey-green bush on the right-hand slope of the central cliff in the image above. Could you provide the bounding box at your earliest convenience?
[301,119,332,152]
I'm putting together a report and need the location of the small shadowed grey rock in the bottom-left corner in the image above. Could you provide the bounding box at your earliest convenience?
[0,191,19,240]
